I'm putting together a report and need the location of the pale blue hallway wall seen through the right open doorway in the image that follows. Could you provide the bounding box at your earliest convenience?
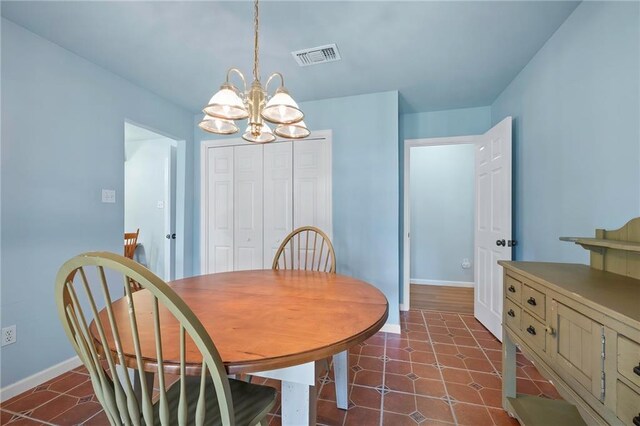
[410,144,475,283]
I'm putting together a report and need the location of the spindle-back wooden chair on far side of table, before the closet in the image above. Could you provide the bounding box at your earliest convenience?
[271,226,336,274]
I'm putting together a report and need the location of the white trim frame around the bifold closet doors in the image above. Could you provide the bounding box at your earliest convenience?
[199,130,333,274]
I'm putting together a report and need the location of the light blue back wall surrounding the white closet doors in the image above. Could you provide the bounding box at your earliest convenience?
[194,92,400,324]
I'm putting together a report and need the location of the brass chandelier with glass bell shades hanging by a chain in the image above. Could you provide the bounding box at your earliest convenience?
[198,0,310,143]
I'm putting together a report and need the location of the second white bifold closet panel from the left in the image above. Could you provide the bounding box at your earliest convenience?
[233,145,263,271]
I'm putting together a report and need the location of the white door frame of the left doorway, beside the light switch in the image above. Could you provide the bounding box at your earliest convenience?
[122,118,187,279]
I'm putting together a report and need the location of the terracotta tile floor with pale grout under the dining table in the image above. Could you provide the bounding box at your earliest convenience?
[0,310,559,426]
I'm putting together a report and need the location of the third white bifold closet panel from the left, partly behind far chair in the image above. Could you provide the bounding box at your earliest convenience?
[263,142,293,269]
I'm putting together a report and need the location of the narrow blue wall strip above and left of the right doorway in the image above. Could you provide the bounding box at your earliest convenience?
[398,106,491,301]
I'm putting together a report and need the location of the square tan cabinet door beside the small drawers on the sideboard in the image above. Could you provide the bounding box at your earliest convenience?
[551,300,604,399]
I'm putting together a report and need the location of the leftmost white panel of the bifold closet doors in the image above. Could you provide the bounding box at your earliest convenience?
[202,147,234,274]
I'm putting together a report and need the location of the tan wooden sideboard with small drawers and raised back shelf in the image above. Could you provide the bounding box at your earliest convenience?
[499,218,640,426]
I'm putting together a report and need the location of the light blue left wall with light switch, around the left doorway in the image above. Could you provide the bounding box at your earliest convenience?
[0,19,193,387]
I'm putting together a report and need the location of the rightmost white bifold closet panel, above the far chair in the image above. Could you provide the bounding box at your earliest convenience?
[293,140,332,238]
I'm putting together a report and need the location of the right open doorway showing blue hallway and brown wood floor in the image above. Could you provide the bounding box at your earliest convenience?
[409,141,475,314]
